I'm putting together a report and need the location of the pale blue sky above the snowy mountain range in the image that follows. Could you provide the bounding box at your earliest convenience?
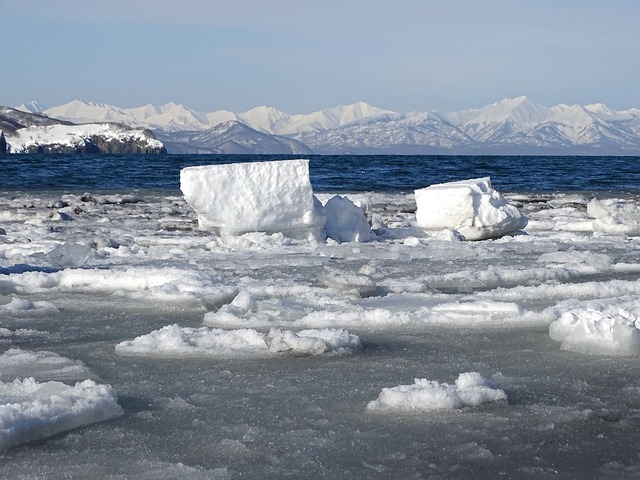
[0,0,640,114]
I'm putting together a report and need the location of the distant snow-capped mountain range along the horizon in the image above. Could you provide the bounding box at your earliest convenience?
[17,96,640,155]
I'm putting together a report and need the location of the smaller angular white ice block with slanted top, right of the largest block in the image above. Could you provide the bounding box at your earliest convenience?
[415,177,527,240]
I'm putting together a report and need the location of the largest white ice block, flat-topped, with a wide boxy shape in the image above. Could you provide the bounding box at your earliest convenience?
[180,160,325,239]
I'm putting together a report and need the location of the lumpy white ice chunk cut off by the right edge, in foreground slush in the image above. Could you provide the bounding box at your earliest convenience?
[549,308,640,355]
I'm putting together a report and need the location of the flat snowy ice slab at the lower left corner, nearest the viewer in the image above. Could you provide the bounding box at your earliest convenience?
[0,378,123,450]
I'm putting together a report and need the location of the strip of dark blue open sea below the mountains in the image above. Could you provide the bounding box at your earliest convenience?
[0,154,640,194]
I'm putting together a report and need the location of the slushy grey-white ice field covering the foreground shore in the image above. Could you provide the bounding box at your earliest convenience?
[0,183,640,479]
